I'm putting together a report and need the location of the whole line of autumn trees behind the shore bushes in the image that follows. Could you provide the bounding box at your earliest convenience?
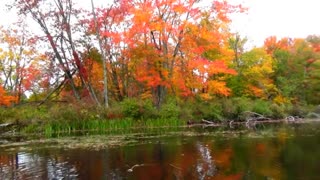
[0,0,320,124]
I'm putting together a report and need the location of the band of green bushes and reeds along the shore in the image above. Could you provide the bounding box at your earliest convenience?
[0,98,320,137]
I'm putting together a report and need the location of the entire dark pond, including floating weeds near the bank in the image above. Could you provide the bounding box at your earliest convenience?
[0,123,320,180]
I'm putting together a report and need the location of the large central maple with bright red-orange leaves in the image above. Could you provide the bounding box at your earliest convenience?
[108,0,243,106]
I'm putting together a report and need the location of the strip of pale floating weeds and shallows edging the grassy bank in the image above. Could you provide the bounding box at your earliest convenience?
[0,119,320,152]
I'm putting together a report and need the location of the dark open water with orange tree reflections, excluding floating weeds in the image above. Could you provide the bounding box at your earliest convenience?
[0,130,320,180]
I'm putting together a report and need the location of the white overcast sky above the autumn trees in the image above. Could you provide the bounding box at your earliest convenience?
[0,0,320,46]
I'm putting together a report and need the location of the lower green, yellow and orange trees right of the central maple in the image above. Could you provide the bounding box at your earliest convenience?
[228,36,320,105]
